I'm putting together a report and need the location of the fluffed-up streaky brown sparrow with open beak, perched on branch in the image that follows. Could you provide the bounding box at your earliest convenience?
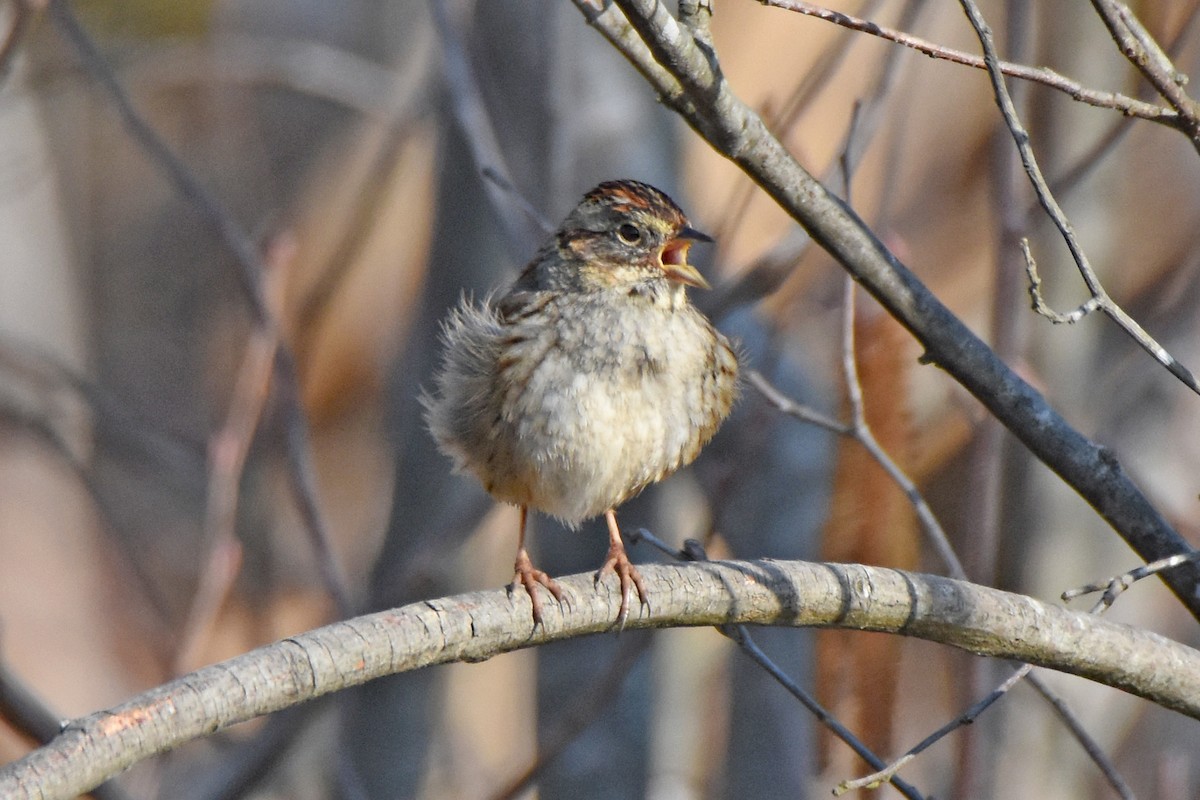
[424,180,738,627]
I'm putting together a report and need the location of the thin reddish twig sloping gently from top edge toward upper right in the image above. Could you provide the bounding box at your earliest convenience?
[758,0,1183,130]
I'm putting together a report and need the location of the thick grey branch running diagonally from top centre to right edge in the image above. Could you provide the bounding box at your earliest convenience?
[574,0,1200,616]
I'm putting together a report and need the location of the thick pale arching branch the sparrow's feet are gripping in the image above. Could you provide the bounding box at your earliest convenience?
[0,560,1200,800]
